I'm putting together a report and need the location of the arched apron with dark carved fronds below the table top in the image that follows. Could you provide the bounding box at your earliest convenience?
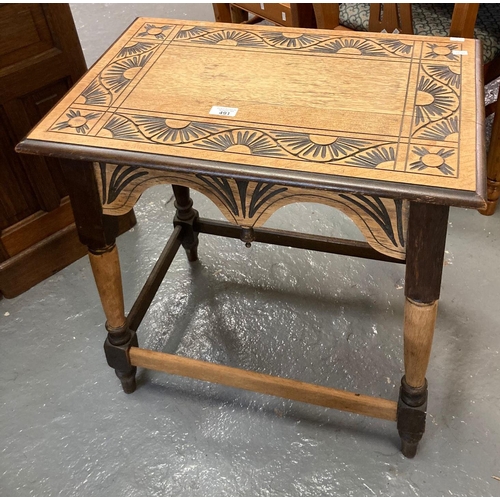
[95,163,408,258]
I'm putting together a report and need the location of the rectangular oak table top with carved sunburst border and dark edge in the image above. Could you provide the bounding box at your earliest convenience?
[17,18,486,207]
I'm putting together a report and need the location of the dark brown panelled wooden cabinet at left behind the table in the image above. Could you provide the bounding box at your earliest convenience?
[0,4,135,298]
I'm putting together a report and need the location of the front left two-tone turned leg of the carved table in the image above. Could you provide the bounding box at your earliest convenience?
[63,160,138,394]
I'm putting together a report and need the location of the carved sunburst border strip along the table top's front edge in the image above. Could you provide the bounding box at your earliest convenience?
[94,113,396,168]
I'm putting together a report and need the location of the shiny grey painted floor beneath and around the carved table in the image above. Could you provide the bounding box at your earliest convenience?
[0,4,500,496]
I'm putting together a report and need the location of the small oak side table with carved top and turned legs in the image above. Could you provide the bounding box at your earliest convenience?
[17,18,486,457]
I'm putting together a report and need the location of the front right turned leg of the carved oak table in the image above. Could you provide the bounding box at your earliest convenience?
[397,203,449,458]
